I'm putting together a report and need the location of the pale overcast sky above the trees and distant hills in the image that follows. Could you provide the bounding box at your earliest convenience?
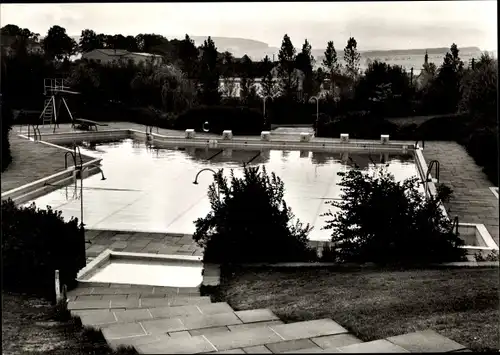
[0,0,497,50]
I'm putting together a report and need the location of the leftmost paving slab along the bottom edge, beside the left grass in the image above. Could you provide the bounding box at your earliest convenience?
[136,336,217,354]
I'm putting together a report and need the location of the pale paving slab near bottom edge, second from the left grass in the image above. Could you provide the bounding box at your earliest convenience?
[205,327,283,351]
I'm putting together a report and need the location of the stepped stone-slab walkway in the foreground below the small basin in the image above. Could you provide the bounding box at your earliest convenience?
[68,283,468,354]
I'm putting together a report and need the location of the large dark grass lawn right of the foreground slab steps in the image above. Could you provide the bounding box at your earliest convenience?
[208,268,500,351]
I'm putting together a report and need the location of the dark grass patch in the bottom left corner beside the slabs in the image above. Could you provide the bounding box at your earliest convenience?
[2,292,135,355]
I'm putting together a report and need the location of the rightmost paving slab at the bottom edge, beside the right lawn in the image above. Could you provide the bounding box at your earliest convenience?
[387,329,465,353]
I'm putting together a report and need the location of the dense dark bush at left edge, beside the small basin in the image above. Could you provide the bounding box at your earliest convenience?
[2,199,86,298]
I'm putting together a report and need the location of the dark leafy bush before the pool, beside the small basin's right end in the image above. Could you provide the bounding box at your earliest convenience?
[193,167,316,264]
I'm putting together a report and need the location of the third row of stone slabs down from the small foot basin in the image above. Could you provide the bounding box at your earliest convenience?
[71,302,233,328]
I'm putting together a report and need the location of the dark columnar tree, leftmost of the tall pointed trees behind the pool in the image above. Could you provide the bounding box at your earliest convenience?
[199,36,220,105]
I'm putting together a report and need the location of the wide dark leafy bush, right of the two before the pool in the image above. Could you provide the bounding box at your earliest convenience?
[324,169,465,265]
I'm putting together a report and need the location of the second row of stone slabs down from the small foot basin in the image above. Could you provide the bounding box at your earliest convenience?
[68,295,211,311]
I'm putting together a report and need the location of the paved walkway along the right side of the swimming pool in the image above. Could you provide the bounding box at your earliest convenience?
[423,141,499,245]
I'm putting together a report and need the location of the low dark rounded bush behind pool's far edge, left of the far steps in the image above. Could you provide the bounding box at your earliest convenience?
[174,106,264,135]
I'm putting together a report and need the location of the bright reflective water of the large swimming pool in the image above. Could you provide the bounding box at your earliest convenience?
[29,139,418,240]
